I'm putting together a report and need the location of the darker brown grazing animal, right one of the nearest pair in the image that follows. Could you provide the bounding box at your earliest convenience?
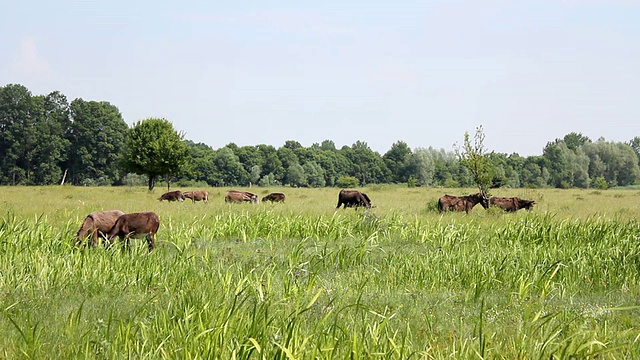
[107,212,160,251]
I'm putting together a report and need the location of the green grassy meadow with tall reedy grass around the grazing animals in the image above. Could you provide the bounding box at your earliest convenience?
[0,185,640,359]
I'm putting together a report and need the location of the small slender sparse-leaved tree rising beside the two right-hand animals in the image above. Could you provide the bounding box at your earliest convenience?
[454,125,494,195]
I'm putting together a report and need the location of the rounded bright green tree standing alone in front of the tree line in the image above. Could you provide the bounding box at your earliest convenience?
[122,118,189,190]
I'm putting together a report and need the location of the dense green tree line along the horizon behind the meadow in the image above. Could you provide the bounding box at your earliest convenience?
[0,84,640,188]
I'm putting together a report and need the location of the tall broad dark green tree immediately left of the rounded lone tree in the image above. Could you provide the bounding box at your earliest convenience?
[67,99,128,185]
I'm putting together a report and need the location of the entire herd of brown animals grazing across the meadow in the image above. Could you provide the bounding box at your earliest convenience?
[76,189,535,251]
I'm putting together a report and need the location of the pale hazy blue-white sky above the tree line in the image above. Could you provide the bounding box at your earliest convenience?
[0,0,640,156]
